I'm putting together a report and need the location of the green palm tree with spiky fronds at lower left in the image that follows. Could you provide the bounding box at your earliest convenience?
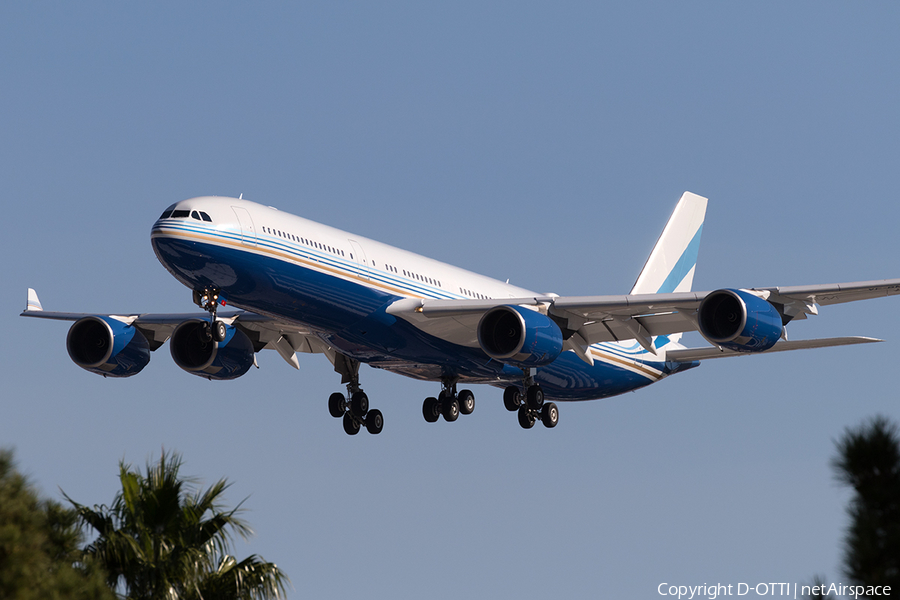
[66,451,288,600]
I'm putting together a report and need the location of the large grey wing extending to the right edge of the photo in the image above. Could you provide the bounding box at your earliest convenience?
[387,279,900,358]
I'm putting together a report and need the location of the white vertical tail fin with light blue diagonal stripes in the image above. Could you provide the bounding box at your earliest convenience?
[631,192,706,294]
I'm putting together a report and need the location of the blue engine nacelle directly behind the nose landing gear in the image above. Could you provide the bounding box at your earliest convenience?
[169,319,253,379]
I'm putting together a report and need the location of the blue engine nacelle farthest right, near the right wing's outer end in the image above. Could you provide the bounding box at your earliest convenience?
[697,289,784,352]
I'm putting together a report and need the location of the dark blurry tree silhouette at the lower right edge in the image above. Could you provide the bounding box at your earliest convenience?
[832,416,900,591]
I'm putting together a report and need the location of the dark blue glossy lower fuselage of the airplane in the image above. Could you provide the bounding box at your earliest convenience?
[152,232,696,400]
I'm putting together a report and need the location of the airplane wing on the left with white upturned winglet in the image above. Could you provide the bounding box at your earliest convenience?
[21,288,326,369]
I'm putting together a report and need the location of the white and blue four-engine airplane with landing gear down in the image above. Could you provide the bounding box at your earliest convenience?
[21,192,900,435]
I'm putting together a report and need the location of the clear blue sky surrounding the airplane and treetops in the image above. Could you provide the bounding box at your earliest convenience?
[0,2,900,599]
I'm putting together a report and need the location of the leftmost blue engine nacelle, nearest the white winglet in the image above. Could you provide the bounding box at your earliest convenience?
[66,316,150,377]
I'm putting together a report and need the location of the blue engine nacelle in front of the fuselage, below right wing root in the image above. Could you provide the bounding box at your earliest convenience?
[478,305,563,367]
